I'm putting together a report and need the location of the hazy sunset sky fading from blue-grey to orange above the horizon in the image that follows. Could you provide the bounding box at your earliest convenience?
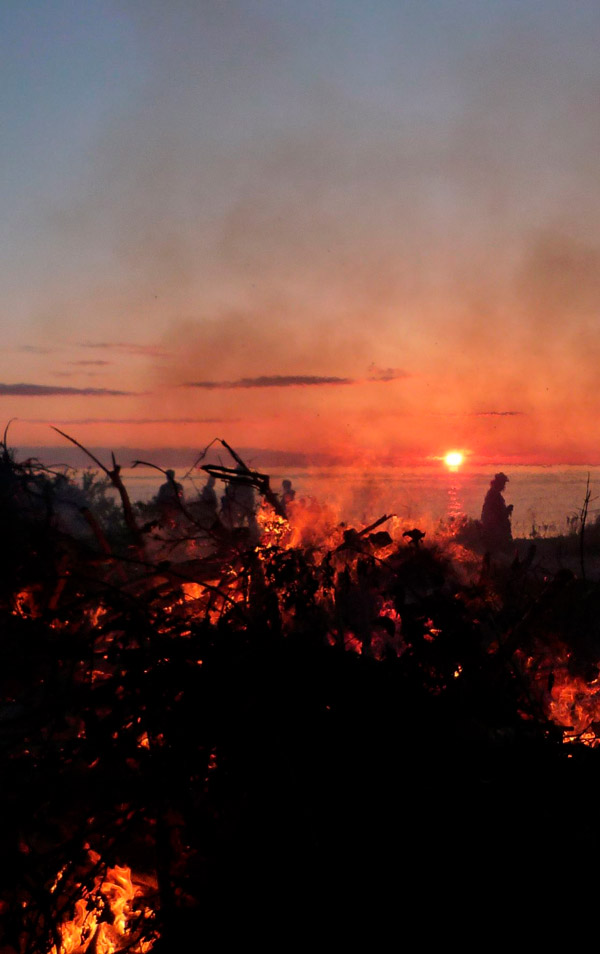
[0,0,600,466]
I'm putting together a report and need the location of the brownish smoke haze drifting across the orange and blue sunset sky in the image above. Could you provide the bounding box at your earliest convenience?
[10,0,600,458]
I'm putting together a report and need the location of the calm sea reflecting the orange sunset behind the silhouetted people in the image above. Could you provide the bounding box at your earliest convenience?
[113,464,600,537]
